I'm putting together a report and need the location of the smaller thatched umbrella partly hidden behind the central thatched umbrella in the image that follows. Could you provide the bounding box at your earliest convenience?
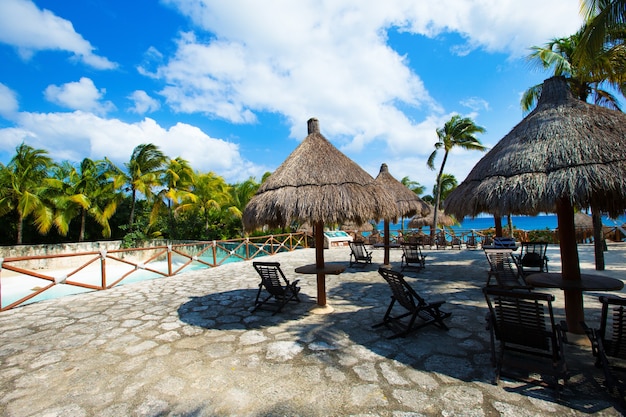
[376,163,430,265]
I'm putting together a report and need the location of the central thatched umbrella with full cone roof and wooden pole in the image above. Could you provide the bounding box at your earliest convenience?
[243,118,398,306]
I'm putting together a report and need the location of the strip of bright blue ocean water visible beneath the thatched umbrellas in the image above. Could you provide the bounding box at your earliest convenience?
[377,214,626,231]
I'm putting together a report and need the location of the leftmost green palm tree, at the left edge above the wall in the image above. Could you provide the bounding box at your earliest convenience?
[0,143,53,245]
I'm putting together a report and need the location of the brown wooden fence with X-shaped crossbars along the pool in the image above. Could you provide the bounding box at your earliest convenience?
[0,233,308,311]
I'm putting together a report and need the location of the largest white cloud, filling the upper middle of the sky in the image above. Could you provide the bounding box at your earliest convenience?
[156,0,581,152]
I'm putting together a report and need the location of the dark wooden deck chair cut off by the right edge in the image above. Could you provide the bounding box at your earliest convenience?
[581,295,626,407]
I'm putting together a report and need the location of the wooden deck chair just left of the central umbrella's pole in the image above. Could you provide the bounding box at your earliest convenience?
[252,262,300,315]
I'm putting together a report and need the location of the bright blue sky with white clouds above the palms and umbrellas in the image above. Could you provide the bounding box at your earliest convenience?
[0,0,581,192]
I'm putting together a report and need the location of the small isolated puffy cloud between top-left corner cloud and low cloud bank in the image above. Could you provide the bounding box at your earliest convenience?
[44,77,115,114]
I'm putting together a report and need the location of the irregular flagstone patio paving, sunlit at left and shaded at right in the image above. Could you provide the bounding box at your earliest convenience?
[0,244,626,417]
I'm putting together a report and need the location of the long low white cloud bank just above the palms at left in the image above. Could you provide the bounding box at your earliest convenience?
[0,111,264,182]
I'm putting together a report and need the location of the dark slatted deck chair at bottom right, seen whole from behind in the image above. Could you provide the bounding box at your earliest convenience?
[483,287,569,394]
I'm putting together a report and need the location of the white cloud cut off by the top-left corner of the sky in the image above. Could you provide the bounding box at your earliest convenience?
[0,0,117,69]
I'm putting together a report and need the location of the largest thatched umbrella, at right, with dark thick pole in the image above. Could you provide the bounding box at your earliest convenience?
[445,77,626,333]
